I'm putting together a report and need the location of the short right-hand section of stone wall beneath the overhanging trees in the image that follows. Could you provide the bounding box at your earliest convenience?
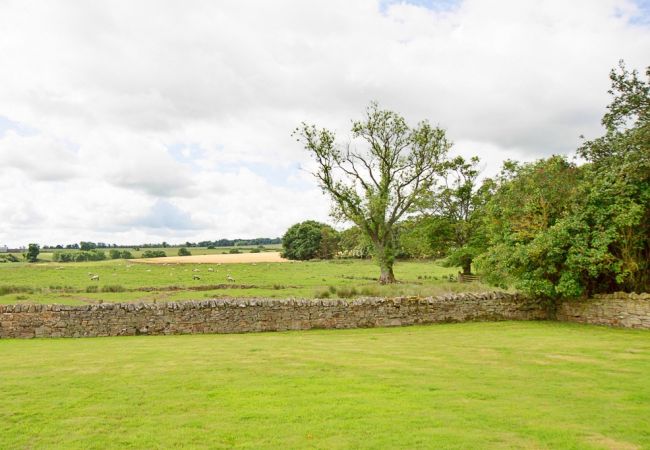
[556,292,650,329]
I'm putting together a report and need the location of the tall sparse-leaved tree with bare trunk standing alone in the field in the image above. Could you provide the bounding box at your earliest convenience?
[294,103,450,283]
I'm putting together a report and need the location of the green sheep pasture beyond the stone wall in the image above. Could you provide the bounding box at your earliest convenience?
[0,260,491,304]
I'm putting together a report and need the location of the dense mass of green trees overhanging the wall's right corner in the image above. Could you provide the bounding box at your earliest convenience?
[481,60,650,298]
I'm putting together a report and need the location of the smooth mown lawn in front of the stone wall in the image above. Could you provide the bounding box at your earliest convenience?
[0,322,650,449]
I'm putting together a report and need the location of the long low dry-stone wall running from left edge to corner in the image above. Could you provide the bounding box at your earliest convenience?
[0,292,548,338]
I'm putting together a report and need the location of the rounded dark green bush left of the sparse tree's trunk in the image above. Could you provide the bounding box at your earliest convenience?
[282,220,339,261]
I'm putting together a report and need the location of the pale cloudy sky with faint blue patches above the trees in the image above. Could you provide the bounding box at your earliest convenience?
[0,0,650,247]
